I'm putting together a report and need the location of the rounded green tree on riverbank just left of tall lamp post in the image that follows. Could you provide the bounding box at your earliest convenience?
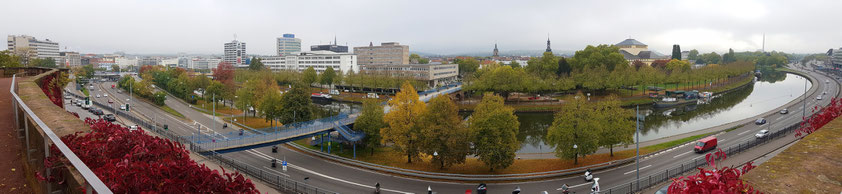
[596,94,634,157]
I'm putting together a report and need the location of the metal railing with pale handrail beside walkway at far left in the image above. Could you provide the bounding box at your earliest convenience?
[9,75,112,194]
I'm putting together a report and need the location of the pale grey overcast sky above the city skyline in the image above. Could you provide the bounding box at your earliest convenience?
[0,0,842,55]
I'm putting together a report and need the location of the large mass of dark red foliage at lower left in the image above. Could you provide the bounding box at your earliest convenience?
[38,119,259,193]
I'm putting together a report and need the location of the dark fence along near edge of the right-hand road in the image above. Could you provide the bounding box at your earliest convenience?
[602,123,801,194]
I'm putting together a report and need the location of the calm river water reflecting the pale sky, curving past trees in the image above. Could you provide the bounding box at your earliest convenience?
[314,72,812,153]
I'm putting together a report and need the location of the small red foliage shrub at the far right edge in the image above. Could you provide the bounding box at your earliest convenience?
[795,98,842,137]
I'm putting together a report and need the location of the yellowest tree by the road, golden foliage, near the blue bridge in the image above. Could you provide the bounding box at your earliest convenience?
[380,81,426,163]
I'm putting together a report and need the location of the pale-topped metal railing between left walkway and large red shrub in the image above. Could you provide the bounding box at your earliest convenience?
[9,75,112,193]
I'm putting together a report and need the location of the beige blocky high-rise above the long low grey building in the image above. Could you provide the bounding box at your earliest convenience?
[354,42,409,65]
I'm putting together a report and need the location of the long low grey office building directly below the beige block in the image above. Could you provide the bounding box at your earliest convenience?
[360,63,459,87]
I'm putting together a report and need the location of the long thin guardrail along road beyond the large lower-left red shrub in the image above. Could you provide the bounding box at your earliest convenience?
[68,88,338,194]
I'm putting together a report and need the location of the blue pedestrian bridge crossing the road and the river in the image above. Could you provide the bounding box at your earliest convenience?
[182,84,462,153]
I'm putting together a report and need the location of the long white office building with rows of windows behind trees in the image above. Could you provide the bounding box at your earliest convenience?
[260,51,359,73]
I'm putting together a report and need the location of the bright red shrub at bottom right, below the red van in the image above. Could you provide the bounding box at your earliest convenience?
[668,149,760,194]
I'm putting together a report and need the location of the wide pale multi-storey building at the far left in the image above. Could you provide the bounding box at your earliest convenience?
[7,35,61,64]
